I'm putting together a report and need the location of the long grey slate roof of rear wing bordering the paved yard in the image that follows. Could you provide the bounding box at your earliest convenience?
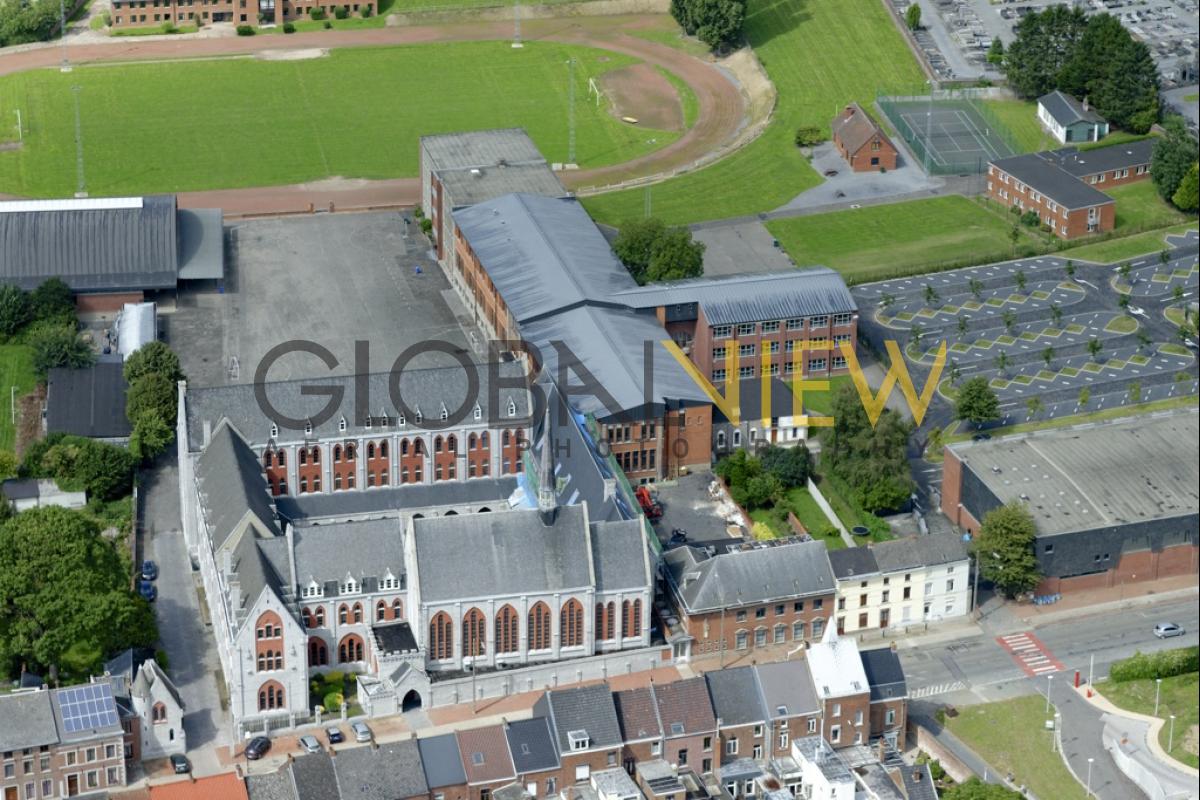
[187,362,529,450]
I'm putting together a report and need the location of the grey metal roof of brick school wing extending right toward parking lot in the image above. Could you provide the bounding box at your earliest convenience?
[613,266,858,325]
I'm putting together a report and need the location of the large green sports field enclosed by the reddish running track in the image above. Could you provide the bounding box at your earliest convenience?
[0,42,679,197]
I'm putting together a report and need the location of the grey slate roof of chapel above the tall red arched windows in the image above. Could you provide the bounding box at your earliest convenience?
[413,506,592,602]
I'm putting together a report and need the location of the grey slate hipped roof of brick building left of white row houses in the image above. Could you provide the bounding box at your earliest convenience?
[664,542,834,613]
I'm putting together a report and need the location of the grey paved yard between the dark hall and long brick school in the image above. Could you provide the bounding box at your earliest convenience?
[166,212,486,386]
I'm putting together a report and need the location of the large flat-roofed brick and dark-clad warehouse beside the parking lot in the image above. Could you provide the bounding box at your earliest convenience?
[942,409,1200,594]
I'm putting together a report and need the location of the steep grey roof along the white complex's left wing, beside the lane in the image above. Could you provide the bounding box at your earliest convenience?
[196,425,280,547]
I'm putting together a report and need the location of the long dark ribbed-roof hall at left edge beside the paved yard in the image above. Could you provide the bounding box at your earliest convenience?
[0,194,224,313]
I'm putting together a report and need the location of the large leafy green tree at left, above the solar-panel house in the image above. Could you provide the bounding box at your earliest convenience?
[0,506,157,678]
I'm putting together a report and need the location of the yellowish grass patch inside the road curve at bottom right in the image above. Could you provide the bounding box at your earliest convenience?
[946,697,1086,800]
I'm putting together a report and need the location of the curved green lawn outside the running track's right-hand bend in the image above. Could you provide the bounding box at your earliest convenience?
[584,0,923,224]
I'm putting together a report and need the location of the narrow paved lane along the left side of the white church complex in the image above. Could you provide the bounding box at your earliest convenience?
[142,450,230,775]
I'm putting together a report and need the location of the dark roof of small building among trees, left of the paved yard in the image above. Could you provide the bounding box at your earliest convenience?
[45,367,133,439]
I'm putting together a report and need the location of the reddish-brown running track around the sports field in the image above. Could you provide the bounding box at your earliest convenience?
[0,16,746,216]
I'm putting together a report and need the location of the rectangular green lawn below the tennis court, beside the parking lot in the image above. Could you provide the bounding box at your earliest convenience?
[767,194,1032,283]
